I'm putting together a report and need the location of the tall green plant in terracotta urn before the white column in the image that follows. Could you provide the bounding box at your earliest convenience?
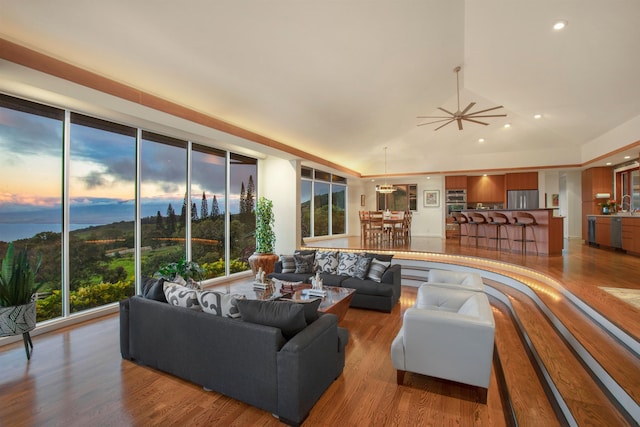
[249,197,278,275]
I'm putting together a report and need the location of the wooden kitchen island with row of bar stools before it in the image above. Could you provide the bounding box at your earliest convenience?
[460,209,564,255]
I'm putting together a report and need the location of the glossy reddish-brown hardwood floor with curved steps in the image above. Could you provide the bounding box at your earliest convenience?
[0,238,640,426]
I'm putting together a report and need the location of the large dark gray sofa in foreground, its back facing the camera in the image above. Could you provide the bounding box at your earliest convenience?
[120,296,349,425]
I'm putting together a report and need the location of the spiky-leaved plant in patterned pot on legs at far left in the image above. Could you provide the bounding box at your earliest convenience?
[0,242,42,359]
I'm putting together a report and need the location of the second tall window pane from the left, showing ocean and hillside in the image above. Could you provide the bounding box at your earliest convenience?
[68,113,137,313]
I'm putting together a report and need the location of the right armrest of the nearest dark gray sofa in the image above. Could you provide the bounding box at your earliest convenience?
[278,314,344,423]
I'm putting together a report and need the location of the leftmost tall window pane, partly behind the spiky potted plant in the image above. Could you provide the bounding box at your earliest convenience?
[0,94,64,321]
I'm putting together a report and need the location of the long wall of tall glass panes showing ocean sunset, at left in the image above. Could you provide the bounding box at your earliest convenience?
[0,94,257,321]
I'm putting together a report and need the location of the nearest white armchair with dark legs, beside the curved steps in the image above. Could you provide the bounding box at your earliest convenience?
[391,285,495,399]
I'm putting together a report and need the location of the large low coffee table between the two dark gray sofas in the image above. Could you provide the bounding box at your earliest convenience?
[212,281,356,321]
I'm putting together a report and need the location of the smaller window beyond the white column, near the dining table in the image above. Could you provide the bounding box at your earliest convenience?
[300,167,347,237]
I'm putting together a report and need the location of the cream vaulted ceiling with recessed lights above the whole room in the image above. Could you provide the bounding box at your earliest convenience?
[0,0,640,176]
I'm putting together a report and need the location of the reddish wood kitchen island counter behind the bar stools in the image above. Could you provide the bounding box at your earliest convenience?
[461,209,564,255]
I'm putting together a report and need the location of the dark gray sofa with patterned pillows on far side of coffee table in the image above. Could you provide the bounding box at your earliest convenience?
[267,250,402,312]
